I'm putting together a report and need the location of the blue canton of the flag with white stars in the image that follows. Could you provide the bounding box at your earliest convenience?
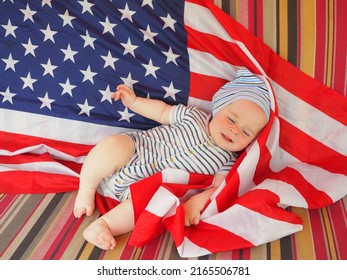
[0,0,189,129]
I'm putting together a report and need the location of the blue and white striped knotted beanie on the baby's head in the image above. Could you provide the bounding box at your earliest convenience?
[212,69,271,121]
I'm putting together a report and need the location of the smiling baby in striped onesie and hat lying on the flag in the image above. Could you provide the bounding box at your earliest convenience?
[74,69,270,250]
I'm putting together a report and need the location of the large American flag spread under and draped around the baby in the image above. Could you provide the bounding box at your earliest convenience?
[0,0,347,257]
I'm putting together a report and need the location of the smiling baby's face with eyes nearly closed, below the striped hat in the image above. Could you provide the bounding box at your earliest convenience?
[209,100,267,152]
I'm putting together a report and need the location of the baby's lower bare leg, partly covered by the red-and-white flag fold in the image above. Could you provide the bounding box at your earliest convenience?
[83,199,134,250]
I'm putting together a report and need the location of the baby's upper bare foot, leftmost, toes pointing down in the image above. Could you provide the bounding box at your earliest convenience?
[74,189,95,218]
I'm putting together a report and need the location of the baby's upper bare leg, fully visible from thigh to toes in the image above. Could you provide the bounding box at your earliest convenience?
[74,134,134,218]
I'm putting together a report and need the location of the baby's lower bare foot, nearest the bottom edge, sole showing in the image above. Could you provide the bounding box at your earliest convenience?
[83,218,116,250]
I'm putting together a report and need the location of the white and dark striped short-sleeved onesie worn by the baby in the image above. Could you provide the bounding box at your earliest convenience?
[103,104,236,201]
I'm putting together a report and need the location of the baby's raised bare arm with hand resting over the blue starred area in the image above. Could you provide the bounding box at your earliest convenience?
[112,84,172,124]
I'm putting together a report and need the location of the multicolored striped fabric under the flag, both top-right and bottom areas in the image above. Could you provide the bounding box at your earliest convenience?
[0,0,347,260]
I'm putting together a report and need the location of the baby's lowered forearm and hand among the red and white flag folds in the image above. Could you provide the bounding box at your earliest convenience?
[183,174,225,227]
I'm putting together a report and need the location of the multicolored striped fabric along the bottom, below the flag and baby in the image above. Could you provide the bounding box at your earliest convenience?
[0,193,347,260]
